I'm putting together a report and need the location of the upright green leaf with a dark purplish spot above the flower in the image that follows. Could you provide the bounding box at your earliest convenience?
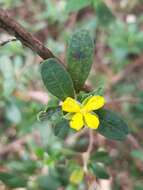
[66,30,94,91]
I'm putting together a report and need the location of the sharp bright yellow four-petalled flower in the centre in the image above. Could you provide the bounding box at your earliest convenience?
[62,96,105,131]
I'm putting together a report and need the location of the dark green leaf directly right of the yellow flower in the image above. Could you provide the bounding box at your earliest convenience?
[96,109,129,141]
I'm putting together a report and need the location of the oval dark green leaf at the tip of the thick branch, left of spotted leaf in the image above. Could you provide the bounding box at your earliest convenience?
[41,58,74,100]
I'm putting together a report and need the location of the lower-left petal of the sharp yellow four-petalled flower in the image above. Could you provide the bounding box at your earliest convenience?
[70,113,84,131]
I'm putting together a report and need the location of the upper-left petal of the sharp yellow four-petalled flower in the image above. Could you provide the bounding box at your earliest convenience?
[62,97,80,113]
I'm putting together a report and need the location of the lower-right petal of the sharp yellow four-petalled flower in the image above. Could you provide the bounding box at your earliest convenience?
[84,113,99,129]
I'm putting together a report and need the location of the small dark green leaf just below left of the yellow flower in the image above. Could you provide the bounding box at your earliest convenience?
[53,119,70,139]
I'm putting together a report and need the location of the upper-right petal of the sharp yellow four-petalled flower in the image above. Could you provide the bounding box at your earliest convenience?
[83,96,105,112]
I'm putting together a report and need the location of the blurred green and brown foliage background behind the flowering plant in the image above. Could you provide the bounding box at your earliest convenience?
[0,0,143,190]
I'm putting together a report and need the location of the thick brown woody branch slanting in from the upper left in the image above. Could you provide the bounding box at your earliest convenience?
[0,8,55,59]
